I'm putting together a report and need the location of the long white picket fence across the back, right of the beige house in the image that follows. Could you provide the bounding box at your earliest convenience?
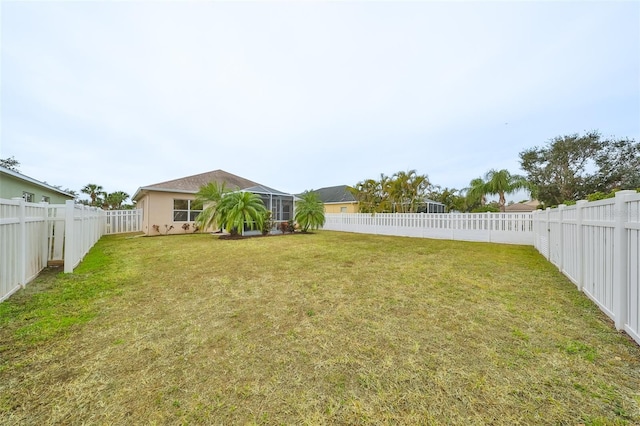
[322,213,533,245]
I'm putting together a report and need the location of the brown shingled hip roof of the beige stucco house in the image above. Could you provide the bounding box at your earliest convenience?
[133,170,261,200]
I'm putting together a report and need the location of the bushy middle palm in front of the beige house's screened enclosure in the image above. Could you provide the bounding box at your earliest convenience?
[213,191,267,235]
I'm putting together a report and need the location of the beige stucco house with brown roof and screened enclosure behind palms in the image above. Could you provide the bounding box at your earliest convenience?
[133,170,295,235]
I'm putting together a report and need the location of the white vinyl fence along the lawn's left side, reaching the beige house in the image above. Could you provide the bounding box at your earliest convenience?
[0,199,142,301]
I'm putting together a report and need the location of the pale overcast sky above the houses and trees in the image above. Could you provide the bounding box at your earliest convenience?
[0,0,640,205]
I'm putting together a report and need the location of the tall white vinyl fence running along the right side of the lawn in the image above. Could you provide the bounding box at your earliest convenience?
[533,191,640,344]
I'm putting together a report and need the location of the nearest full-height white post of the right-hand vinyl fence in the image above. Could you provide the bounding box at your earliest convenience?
[613,190,635,330]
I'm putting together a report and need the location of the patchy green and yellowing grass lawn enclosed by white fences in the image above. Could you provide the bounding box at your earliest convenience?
[0,231,640,425]
